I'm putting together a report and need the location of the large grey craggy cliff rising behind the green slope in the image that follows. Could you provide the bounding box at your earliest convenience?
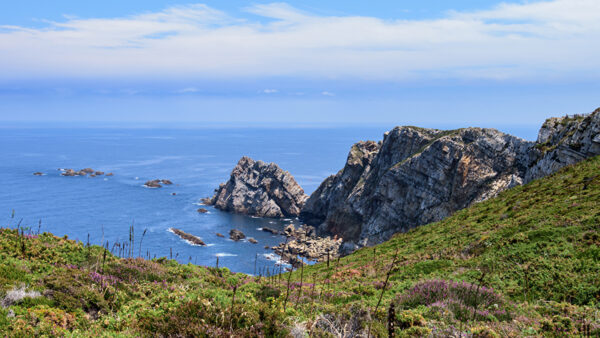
[301,110,600,251]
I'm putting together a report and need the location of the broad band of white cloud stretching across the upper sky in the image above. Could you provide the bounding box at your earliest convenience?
[0,0,600,81]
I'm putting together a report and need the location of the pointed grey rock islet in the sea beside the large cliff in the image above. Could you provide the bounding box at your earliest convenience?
[207,157,308,217]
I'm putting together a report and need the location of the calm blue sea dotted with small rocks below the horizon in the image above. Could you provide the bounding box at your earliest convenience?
[0,126,535,274]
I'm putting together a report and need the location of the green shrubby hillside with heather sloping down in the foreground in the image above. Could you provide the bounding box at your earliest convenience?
[0,157,600,336]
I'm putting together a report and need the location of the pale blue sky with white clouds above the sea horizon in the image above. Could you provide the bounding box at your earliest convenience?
[0,0,600,135]
